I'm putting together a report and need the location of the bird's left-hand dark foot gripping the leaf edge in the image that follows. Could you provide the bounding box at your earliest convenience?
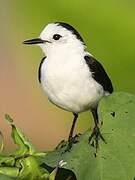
[65,133,81,152]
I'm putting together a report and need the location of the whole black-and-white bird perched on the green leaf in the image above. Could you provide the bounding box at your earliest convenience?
[23,22,113,149]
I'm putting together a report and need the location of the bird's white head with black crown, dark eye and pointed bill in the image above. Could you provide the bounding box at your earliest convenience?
[24,22,85,55]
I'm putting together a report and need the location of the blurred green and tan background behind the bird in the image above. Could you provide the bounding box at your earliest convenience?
[0,0,135,151]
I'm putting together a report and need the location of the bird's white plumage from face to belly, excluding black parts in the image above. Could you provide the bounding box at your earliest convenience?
[40,24,104,113]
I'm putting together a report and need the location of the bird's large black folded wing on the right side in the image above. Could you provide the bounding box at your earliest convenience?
[84,55,113,93]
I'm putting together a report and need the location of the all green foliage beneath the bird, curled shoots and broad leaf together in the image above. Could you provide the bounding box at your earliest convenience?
[0,93,135,180]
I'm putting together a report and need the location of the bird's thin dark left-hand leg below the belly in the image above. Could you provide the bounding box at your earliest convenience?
[66,113,78,151]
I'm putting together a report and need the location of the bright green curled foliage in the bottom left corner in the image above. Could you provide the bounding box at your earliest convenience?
[0,115,49,180]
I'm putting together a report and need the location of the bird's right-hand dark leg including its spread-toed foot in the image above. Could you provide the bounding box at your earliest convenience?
[89,107,105,151]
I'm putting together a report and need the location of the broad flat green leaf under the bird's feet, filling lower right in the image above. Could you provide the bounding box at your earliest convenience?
[44,92,135,180]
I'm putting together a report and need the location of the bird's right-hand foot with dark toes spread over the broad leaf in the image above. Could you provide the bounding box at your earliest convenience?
[89,126,106,153]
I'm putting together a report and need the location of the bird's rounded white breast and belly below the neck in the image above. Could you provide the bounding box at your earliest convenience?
[41,49,104,113]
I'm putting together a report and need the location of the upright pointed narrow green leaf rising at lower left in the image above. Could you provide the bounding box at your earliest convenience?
[5,114,35,157]
